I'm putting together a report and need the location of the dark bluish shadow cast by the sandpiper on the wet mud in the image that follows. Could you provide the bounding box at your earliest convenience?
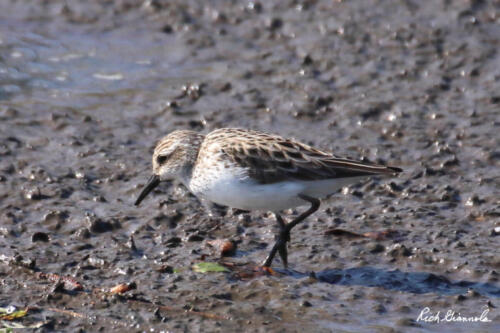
[277,266,500,298]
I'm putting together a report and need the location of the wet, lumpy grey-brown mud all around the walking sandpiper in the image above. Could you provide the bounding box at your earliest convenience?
[0,0,500,332]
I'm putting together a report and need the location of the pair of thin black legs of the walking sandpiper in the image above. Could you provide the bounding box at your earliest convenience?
[263,194,320,268]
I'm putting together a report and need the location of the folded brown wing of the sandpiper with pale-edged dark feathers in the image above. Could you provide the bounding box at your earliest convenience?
[212,129,401,184]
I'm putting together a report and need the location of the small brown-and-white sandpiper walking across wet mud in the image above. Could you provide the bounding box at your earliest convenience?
[135,128,402,268]
